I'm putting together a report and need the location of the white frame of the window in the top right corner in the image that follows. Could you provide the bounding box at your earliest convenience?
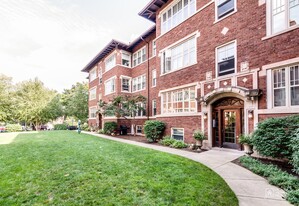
[266,0,299,36]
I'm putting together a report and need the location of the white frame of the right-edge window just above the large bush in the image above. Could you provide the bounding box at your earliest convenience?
[267,63,299,109]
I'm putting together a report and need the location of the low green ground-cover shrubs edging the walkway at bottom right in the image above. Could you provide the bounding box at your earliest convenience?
[240,157,299,205]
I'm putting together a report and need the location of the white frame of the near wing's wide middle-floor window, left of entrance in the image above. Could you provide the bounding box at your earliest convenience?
[161,35,197,75]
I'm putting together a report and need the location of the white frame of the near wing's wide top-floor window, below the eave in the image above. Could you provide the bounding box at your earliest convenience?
[160,0,197,35]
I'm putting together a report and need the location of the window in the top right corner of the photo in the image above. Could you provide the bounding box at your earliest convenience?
[269,0,299,34]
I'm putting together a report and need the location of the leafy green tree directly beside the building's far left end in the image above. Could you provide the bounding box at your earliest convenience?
[61,82,88,122]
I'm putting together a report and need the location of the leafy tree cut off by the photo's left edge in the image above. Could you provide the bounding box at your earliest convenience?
[0,74,14,122]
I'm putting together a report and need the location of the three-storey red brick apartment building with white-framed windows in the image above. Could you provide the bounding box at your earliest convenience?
[82,0,299,149]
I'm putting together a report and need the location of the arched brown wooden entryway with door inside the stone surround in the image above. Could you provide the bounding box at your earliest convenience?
[211,97,244,149]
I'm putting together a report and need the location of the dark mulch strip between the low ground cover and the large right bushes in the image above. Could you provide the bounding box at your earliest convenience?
[232,157,299,178]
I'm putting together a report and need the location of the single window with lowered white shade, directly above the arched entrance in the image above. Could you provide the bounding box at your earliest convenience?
[217,42,236,76]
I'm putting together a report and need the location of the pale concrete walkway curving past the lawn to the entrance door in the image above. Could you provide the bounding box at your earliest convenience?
[84,132,291,206]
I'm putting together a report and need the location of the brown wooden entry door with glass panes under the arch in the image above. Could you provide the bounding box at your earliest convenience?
[221,109,241,149]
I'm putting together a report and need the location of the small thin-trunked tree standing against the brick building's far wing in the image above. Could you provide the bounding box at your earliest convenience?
[99,95,146,135]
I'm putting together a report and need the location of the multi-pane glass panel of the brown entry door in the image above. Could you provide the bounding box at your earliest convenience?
[223,111,236,143]
